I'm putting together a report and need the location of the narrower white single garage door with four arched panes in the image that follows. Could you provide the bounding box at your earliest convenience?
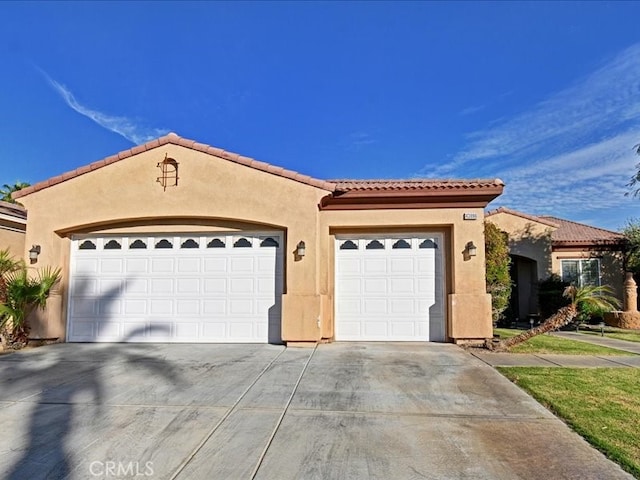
[335,234,445,341]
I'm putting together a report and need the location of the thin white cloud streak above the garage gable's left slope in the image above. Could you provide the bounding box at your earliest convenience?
[36,67,169,145]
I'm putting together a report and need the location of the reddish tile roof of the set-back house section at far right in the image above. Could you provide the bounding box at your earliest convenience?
[485,207,625,246]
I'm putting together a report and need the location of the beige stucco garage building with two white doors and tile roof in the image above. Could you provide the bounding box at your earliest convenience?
[14,133,503,345]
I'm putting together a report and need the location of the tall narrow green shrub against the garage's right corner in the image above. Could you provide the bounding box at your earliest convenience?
[484,222,511,325]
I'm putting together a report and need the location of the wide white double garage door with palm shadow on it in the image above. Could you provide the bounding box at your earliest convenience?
[67,233,283,343]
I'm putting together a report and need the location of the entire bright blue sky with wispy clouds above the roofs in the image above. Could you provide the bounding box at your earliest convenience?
[0,1,640,229]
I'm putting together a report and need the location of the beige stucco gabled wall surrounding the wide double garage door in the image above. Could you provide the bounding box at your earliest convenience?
[21,144,327,340]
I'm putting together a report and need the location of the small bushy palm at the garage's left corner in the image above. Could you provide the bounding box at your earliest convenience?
[0,263,60,344]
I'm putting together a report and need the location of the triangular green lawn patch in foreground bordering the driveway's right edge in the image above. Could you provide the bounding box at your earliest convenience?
[498,367,640,478]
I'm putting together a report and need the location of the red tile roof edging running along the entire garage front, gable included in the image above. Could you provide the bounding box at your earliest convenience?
[13,133,504,198]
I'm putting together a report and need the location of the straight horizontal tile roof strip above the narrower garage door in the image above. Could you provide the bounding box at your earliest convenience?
[329,178,504,192]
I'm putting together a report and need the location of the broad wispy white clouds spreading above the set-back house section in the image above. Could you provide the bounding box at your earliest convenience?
[423,44,640,228]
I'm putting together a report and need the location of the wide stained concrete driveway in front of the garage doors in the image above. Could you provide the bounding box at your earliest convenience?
[0,343,632,480]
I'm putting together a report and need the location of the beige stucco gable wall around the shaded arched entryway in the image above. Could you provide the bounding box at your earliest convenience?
[487,212,555,280]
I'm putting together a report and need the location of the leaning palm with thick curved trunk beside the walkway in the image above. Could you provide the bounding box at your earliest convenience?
[487,285,620,352]
